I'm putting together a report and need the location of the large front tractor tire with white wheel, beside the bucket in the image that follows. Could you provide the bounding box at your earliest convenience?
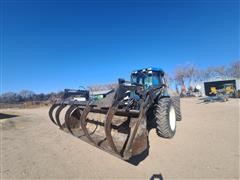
[154,98,176,138]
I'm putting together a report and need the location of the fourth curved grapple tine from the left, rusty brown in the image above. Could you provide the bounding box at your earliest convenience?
[78,103,96,145]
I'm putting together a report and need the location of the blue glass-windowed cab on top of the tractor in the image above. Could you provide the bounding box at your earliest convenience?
[131,68,166,89]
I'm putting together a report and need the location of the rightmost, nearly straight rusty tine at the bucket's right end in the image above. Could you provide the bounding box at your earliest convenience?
[123,96,149,159]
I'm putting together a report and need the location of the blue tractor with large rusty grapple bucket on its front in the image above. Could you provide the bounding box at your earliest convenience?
[49,68,181,160]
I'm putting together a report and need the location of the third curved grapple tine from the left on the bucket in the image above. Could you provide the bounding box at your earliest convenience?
[65,104,81,136]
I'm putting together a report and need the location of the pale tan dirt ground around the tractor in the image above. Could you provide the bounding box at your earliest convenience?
[0,98,240,179]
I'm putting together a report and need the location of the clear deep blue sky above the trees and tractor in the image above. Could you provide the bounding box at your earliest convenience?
[0,0,239,93]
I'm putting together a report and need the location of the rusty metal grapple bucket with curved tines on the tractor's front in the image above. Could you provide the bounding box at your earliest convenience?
[49,85,148,160]
